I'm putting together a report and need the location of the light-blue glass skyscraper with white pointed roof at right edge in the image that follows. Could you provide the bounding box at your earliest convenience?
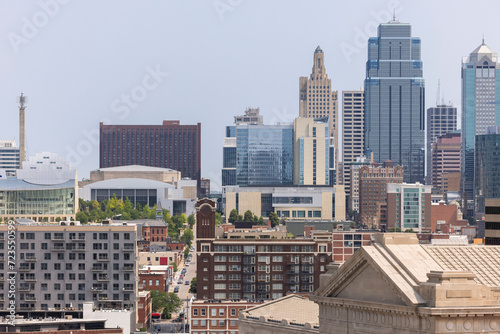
[462,38,500,214]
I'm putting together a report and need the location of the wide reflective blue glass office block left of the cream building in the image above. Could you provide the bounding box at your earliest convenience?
[236,124,293,186]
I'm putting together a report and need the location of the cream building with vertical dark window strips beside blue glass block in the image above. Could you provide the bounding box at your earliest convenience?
[293,117,330,185]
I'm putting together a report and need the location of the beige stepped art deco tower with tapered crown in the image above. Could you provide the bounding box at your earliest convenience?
[299,46,339,172]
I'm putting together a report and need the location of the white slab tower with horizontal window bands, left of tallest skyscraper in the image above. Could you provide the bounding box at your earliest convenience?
[338,90,365,197]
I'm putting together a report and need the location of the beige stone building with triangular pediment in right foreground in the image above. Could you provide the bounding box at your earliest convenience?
[311,233,500,334]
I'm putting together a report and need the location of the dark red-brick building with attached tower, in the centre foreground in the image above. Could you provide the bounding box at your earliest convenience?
[196,199,332,300]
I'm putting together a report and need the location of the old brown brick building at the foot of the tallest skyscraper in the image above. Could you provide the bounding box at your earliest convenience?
[359,161,404,226]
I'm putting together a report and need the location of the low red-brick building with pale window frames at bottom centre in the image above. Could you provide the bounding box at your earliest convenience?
[189,300,262,334]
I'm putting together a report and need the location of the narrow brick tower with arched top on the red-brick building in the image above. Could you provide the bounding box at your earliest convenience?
[196,199,215,299]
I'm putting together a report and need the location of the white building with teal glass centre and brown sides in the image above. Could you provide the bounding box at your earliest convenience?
[387,182,432,233]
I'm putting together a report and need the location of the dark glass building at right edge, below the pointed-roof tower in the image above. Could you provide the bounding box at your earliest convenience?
[474,127,500,214]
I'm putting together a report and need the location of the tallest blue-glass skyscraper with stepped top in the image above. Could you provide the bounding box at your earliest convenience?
[365,20,425,183]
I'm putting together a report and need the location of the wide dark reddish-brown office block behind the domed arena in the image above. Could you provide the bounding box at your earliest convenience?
[99,121,201,185]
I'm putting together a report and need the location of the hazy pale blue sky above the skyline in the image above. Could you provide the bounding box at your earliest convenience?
[0,0,500,188]
